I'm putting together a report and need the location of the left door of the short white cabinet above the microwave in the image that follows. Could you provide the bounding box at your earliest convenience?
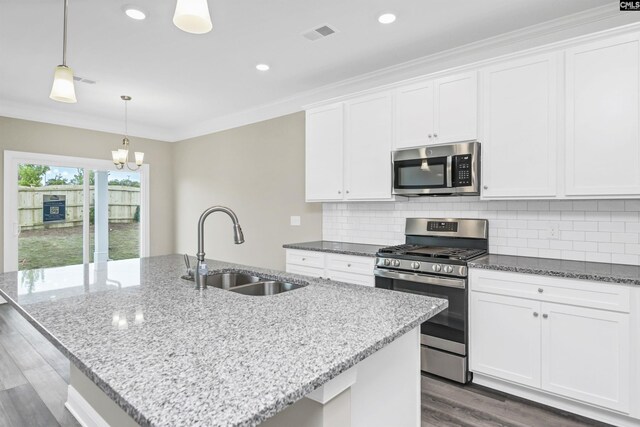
[394,80,435,149]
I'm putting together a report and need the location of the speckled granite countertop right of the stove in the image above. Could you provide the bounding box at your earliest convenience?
[468,255,640,285]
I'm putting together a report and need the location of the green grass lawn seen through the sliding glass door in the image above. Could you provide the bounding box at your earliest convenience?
[18,223,140,270]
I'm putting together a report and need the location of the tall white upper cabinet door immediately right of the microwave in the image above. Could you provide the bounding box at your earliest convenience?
[482,54,558,198]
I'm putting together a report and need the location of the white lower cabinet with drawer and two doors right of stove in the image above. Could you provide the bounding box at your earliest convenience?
[469,269,638,417]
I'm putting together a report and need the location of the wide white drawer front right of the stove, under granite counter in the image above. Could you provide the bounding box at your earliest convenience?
[470,269,630,313]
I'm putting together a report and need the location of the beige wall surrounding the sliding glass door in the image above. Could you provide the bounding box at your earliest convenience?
[0,117,174,271]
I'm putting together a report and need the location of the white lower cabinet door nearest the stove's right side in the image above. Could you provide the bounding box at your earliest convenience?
[469,292,540,387]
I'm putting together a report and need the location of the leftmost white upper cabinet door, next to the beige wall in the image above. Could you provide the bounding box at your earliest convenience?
[305,104,344,201]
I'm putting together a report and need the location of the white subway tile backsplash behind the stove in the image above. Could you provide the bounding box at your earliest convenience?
[322,197,640,265]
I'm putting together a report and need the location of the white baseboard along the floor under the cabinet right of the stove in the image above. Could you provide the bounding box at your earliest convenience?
[473,372,640,427]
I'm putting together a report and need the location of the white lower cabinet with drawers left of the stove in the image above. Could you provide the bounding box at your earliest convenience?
[287,249,375,286]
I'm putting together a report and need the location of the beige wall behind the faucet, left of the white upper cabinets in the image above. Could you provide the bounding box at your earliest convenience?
[173,112,322,269]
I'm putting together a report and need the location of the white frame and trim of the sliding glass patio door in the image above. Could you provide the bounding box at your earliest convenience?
[3,150,151,272]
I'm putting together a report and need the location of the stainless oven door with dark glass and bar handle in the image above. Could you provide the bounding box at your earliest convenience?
[375,268,468,356]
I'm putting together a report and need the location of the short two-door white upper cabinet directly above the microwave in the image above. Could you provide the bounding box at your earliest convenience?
[394,71,478,149]
